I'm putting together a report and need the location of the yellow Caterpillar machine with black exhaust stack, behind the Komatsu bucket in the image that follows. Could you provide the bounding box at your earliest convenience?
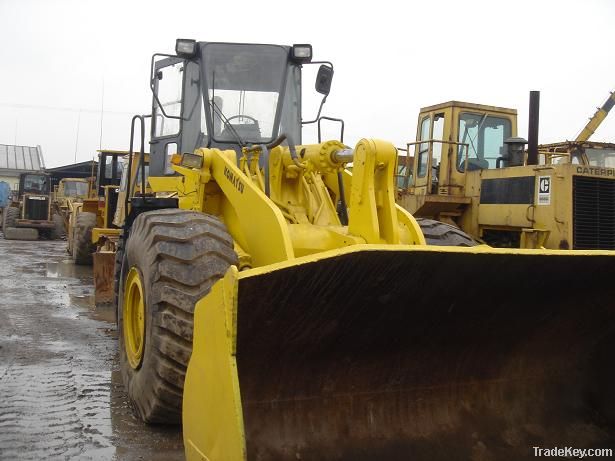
[398,92,615,250]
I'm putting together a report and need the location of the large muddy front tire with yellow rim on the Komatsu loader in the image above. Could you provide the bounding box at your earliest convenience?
[118,209,238,424]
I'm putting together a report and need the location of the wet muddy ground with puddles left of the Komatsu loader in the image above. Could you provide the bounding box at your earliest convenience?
[0,237,183,461]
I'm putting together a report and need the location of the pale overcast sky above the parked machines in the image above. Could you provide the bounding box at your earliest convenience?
[0,0,615,166]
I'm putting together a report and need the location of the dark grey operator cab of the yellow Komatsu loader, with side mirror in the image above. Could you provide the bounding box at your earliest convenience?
[150,39,333,176]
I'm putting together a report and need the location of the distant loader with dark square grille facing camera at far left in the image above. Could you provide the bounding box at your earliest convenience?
[2,173,63,240]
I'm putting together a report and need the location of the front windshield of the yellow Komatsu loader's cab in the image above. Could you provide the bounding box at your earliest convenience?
[202,43,288,145]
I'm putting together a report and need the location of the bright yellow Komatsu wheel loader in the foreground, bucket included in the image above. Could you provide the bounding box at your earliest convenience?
[116,40,615,461]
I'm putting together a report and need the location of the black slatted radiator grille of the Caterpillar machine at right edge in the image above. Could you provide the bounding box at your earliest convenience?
[572,176,615,250]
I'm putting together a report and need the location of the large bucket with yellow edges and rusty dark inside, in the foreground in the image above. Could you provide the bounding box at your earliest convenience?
[184,245,615,461]
